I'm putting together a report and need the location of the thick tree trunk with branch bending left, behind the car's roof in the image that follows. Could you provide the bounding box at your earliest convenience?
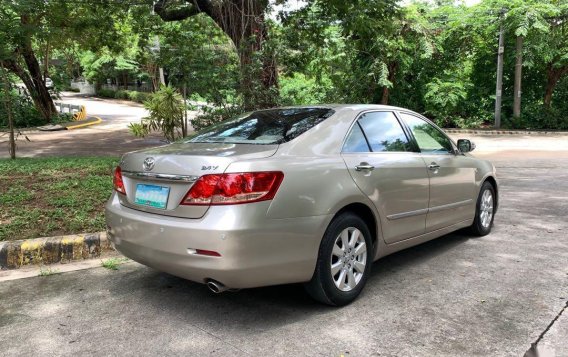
[154,0,278,109]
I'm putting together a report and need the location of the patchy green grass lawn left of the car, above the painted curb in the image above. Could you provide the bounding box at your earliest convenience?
[0,157,118,241]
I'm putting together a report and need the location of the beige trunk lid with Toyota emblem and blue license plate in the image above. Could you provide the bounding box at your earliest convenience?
[119,143,278,218]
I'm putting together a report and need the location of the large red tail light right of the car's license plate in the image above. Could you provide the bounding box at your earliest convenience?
[181,171,284,205]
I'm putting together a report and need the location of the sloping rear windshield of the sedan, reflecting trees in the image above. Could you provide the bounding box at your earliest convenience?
[184,108,334,145]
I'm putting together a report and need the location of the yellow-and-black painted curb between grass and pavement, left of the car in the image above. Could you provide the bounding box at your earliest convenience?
[0,232,113,269]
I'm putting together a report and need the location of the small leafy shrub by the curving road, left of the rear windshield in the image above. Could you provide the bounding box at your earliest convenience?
[129,86,185,141]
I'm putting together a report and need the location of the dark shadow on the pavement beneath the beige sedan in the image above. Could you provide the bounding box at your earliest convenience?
[111,232,470,332]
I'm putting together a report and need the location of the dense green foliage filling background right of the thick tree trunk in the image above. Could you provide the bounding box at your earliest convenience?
[273,0,568,128]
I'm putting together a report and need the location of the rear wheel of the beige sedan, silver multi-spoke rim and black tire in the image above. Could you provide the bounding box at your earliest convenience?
[305,212,373,306]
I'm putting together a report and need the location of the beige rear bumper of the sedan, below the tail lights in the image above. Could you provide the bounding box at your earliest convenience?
[106,193,332,288]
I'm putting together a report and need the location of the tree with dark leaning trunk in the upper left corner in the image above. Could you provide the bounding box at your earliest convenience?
[0,0,132,122]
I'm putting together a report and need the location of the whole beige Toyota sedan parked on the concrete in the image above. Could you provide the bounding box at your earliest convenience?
[106,105,498,305]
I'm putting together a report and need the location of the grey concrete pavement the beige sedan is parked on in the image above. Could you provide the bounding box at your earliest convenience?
[0,153,568,356]
